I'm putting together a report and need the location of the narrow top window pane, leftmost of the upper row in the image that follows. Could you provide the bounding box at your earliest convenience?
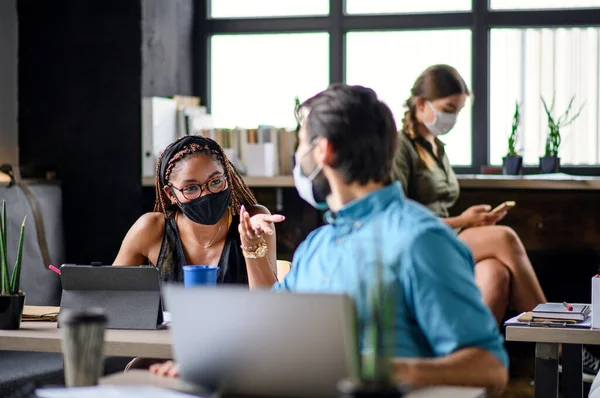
[208,0,329,18]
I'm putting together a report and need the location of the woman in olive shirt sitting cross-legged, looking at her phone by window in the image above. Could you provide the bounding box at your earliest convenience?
[393,65,546,323]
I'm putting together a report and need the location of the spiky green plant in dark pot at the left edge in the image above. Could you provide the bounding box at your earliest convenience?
[0,201,27,329]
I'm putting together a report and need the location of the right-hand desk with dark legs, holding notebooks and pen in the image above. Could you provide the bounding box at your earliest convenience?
[506,326,600,398]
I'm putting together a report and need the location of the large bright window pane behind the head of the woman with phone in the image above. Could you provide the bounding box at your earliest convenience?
[346,30,472,165]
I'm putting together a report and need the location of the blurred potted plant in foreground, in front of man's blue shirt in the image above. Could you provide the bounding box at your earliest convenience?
[337,247,409,398]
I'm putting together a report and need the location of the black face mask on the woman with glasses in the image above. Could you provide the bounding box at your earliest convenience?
[175,188,231,225]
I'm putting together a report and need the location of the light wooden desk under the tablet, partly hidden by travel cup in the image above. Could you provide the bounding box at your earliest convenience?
[0,322,172,359]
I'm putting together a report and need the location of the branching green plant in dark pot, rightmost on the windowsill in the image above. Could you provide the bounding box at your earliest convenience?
[540,96,585,173]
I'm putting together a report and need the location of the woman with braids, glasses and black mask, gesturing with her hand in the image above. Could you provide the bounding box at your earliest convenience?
[114,136,284,285]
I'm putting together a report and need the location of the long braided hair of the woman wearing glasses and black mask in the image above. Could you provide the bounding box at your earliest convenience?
[154,135,257,218]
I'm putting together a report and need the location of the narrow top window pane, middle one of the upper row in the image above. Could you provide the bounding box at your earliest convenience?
[346,0,471,14]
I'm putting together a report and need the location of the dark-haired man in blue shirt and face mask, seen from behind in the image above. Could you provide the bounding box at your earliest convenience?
[247,84,508,390]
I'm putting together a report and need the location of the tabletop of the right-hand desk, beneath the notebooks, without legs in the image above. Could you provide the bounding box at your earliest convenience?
[506,326,600,345]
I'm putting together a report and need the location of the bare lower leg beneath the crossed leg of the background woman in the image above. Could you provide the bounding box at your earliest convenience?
[475,258,510,324]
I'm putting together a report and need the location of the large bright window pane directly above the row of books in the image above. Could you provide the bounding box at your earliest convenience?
[210,33,329,128]
